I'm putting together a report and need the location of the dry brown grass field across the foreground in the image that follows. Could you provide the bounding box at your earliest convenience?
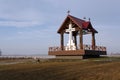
[0,59,120,80]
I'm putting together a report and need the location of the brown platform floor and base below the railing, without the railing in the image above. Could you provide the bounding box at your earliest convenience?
[48,50,107,59]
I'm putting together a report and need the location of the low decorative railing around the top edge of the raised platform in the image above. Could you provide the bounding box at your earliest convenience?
[49,45,106,51]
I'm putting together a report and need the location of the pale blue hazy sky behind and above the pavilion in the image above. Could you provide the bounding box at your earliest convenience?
[0,0,120,55]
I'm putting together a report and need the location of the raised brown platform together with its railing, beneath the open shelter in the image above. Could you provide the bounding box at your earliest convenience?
[48,45,107,59]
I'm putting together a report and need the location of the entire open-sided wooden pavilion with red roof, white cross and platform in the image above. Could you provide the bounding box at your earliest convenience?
[48,14,107,59]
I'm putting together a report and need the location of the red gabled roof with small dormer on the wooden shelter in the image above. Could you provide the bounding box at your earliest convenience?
[58,15,98,33]
